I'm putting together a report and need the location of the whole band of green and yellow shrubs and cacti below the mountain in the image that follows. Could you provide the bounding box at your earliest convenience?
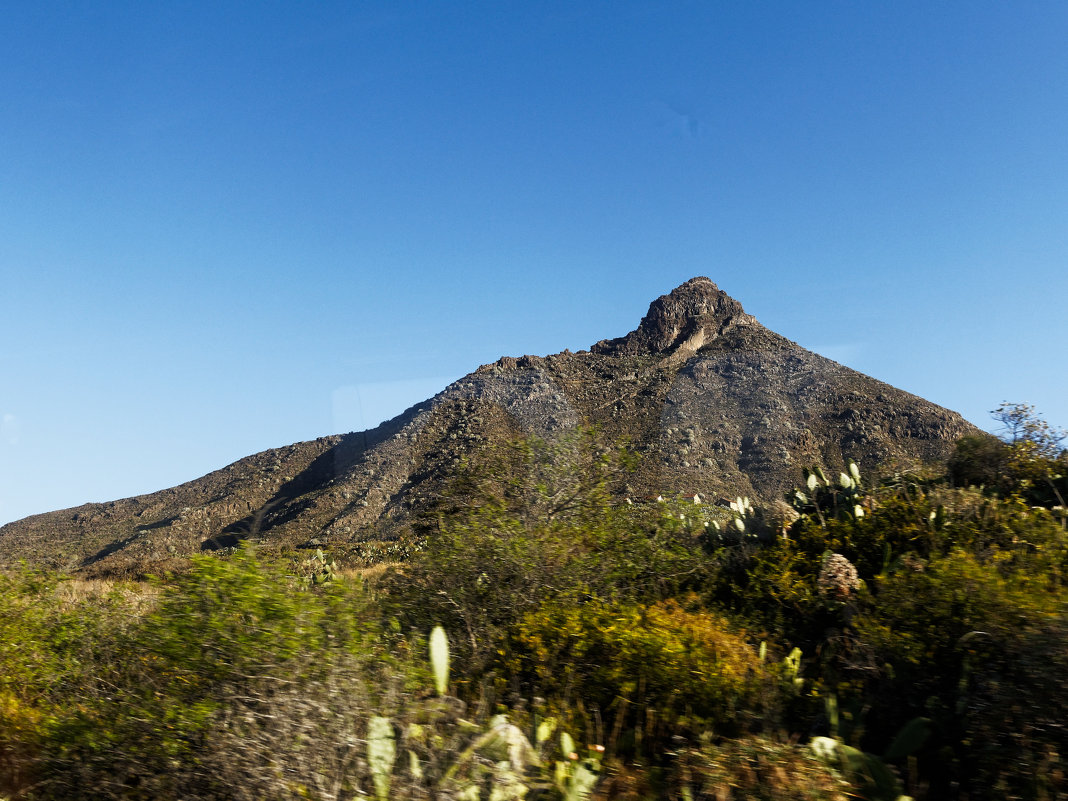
[0,407,1068,801]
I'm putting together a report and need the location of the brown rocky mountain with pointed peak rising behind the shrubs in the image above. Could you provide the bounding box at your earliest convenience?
[0,278,976,576]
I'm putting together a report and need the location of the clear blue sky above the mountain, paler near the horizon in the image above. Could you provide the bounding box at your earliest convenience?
[0,0,1068,522]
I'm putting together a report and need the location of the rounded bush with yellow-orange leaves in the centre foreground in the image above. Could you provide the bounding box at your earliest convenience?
[514,598,765,753]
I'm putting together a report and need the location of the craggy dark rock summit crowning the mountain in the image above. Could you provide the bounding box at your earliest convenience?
[592,276,761,356]
